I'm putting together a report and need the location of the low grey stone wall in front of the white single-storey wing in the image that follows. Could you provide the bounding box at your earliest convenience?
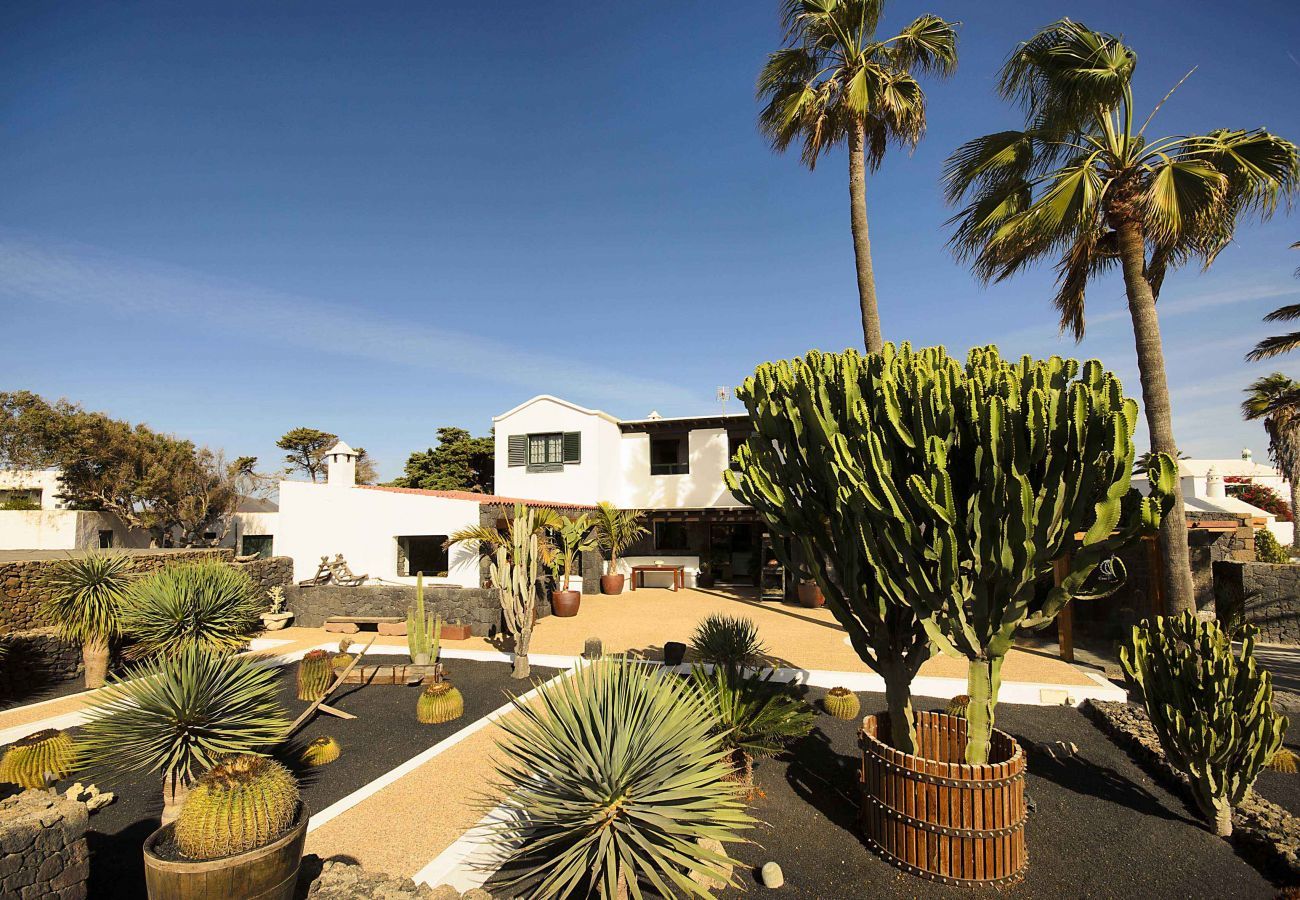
[285,584,533,637]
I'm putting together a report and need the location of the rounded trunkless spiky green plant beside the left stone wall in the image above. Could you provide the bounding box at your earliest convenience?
[122,562,263,658]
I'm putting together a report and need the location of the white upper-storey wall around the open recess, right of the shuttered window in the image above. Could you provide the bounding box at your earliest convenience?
[615,428,744,510]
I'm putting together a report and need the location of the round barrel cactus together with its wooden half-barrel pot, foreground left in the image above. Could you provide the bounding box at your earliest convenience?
[144,754,308,900]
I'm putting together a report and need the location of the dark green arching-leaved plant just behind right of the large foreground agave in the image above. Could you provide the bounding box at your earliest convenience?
[690,666,813,787]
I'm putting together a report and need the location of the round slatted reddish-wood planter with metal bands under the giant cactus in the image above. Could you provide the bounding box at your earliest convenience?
[859,713,1028,886]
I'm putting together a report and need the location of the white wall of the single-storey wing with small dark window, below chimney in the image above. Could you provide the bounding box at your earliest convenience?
[274,481,478,588]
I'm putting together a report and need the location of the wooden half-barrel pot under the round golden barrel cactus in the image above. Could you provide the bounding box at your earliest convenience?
[144,805,309,900]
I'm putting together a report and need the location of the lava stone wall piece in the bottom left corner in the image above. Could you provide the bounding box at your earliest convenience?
[0,791,90,900]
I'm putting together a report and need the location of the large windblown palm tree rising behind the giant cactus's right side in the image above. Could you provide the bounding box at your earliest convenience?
[945,18,1300,613]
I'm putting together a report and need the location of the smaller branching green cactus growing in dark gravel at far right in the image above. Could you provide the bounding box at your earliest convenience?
[1119,613,1287,838]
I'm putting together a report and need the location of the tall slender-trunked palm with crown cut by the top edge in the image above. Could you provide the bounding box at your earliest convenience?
[758,0,957,352]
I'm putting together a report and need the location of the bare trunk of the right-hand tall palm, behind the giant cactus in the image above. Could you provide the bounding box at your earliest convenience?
[1114,213,1196,615]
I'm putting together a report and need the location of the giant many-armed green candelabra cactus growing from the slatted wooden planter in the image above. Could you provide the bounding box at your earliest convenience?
[727,343,1175,763]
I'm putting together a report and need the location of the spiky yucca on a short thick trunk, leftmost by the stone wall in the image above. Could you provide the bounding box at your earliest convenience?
[43,553,131,688]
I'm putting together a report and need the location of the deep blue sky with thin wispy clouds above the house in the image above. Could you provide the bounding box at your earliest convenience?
[0,0,1300,477]
